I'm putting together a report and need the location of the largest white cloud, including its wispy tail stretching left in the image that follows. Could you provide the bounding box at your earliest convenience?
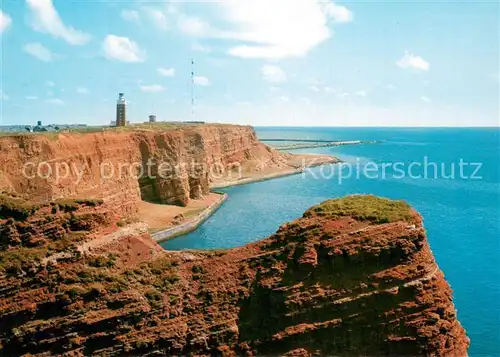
[147,0,353,59]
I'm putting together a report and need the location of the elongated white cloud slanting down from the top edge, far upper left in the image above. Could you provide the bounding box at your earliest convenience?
[26,0,90,45]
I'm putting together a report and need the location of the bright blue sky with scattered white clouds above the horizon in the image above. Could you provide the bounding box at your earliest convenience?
[0,0,500,126]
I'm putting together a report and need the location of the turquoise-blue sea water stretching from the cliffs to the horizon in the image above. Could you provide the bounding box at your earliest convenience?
[162,128,500,356]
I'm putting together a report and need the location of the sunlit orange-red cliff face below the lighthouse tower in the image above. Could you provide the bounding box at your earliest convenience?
[0,125,287,211]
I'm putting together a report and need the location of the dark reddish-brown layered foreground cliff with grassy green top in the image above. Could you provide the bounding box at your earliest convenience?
[0,196,469,356]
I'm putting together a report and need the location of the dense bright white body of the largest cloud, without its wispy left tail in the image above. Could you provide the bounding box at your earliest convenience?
[217,0,352,59]
